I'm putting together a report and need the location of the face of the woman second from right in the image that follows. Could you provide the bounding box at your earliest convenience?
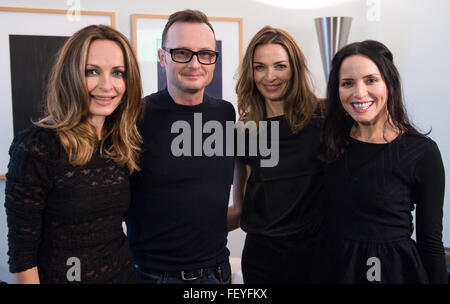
[253,43,292,102]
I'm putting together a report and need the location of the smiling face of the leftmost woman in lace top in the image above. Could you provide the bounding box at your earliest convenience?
[85,40,126,126]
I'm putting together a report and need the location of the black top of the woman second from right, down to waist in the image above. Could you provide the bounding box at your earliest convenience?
[240,116,323,237]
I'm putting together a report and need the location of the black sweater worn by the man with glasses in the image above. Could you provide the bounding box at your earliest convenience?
[126,89,235,272]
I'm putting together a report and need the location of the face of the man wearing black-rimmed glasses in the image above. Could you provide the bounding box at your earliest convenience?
[158,22,216,95]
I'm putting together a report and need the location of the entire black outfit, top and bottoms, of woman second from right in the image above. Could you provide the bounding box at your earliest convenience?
[240,116,323,284]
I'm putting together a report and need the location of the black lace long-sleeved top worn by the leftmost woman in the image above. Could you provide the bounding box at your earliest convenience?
[5,127,137,283]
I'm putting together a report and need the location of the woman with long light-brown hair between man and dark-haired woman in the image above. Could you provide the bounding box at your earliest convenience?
[228,26,322,284]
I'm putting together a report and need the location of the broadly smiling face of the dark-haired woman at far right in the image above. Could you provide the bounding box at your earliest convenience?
[339,55,388,127]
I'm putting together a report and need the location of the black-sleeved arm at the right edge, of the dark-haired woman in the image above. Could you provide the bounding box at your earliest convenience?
[414,143,448,284]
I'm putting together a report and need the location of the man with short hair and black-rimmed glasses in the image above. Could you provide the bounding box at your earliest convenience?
[126,10,235,284]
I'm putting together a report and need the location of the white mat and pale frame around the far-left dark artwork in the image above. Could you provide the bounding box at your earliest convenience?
[0,7,115,179]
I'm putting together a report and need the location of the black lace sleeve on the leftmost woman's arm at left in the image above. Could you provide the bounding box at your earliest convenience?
[5,127,51,273]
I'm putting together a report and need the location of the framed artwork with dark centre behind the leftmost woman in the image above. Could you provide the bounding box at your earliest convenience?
[0,7,115,179]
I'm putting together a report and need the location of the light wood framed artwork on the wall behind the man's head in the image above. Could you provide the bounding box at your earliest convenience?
[132,14,242,105]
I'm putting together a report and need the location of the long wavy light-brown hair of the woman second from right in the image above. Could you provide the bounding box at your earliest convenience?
[236,26,318,133]
